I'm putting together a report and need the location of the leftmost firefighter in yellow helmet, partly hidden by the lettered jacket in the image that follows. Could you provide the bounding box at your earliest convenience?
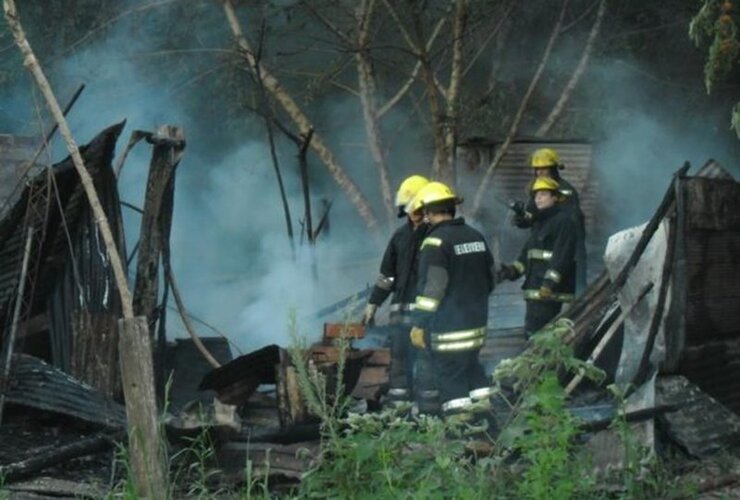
[362,175,429,402]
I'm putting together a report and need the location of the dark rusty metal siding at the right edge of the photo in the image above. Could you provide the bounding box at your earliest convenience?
[673,176,740,414]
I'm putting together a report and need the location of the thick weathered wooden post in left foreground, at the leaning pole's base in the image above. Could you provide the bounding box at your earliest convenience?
[118,316,167,499]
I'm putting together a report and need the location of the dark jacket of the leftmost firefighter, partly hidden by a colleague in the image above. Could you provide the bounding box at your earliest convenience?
[368,221,428,316]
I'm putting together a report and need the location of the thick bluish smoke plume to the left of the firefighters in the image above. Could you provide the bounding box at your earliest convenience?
[0,2,400,352]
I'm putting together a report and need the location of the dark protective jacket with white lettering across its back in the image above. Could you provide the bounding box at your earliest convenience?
[413,218,494,352]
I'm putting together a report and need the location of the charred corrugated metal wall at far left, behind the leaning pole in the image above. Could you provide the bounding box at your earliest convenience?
[0,123,125,382]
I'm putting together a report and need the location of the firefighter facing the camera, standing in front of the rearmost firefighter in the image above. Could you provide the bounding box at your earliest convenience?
[497,177,578,338]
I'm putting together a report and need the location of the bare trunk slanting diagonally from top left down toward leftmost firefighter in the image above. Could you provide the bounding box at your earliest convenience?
[223,0,378,230]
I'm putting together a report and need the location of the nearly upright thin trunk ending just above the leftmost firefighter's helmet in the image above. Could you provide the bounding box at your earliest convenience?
[355,0,395,225]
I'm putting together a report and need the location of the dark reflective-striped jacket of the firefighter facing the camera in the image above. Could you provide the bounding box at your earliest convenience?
[514,205,578,302]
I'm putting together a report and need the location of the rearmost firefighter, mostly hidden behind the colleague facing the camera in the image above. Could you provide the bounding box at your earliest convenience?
[512,148,587,293]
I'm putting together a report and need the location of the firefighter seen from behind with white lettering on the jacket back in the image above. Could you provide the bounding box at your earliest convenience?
[410,182,494,415]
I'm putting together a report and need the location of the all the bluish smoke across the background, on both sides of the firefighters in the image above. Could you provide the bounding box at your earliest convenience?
[2,0,738,351]
